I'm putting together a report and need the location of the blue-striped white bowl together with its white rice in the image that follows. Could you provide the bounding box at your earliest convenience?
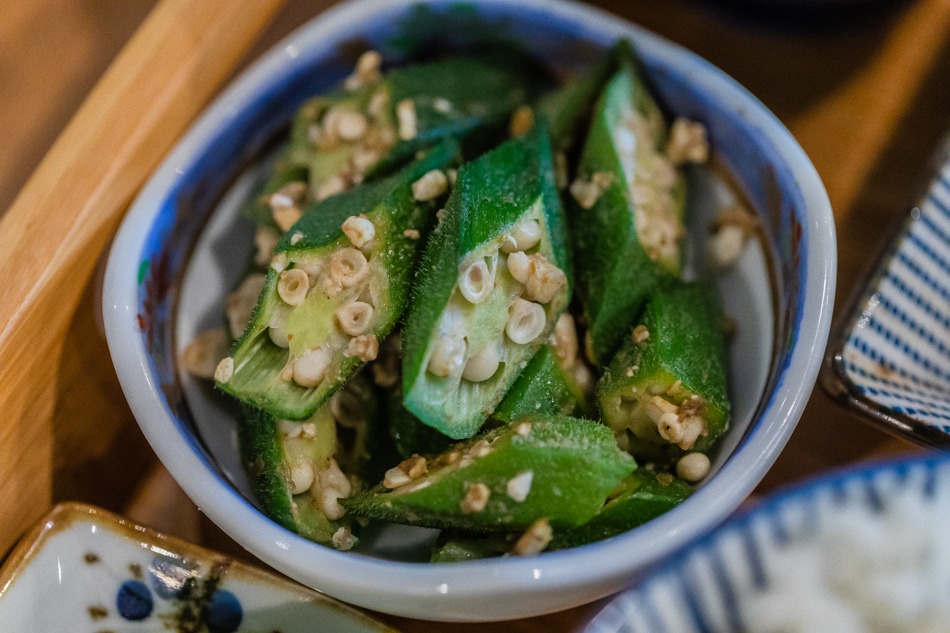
[585,457,950,633]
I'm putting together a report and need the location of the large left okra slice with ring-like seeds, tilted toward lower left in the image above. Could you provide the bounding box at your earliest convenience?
[217,140,457,420]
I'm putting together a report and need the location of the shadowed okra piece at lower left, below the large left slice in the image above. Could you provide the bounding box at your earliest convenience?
[240,377,380,549]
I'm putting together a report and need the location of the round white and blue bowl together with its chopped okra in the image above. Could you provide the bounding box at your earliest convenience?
[105,0,835,620]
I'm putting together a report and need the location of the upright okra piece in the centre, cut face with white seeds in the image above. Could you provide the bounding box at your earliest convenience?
[403,125,570,439]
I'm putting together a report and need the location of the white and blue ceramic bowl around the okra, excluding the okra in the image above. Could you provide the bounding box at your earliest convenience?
[104,0,836,621]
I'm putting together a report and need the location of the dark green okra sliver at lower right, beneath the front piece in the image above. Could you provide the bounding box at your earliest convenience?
[550,469,694,549]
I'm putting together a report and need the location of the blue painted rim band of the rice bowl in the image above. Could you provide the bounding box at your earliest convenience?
[584,454,950,633]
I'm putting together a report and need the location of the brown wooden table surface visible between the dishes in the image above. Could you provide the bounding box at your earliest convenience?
[0,0,950,632]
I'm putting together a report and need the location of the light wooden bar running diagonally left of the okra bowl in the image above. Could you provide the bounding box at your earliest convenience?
[0,0,282,551]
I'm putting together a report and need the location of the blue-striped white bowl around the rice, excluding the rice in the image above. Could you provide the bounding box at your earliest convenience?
[585,457,950,633]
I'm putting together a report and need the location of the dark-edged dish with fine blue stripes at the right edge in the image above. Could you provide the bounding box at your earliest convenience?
[821,133,950,449]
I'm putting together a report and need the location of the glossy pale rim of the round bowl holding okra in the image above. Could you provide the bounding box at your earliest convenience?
[104,0,836,617]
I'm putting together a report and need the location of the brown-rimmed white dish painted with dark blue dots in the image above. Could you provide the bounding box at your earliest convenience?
[0,503,395,633]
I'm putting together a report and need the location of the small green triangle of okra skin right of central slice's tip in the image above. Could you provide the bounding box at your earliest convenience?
[492,345,594,422]
